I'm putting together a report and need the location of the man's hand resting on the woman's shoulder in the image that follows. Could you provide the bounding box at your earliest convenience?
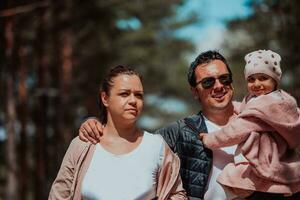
[79,118,103,144]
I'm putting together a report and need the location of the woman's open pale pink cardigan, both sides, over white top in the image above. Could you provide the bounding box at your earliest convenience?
[49,137,187,200]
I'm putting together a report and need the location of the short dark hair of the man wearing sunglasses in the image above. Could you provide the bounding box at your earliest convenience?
[188,51,232,87]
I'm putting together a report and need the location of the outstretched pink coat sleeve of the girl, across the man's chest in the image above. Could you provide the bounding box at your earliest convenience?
[203,116,272,149]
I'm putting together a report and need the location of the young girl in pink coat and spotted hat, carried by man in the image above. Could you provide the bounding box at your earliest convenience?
[200,50,300,197]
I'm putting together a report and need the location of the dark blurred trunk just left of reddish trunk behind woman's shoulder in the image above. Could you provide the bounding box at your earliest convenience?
[35,10,49,200]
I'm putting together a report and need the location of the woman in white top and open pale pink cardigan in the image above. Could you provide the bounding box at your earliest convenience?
[49,66,187,200]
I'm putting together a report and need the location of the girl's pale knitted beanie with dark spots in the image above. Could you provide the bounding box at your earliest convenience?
[244,50,282,85]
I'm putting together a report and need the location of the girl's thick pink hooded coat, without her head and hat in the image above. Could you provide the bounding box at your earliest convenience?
[204,90,300,195]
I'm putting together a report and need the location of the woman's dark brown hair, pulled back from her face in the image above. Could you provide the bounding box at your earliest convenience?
[99,65,142,124]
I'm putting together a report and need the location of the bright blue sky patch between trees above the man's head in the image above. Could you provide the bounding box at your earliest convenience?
[177,0,252,52]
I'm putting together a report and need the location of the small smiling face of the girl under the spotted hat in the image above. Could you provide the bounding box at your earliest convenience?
[247,74,276,96]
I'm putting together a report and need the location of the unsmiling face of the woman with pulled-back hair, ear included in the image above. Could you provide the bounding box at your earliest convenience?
[101,74,144,124]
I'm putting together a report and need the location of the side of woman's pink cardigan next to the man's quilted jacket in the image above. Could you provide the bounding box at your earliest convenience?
[157,144,187,200]
